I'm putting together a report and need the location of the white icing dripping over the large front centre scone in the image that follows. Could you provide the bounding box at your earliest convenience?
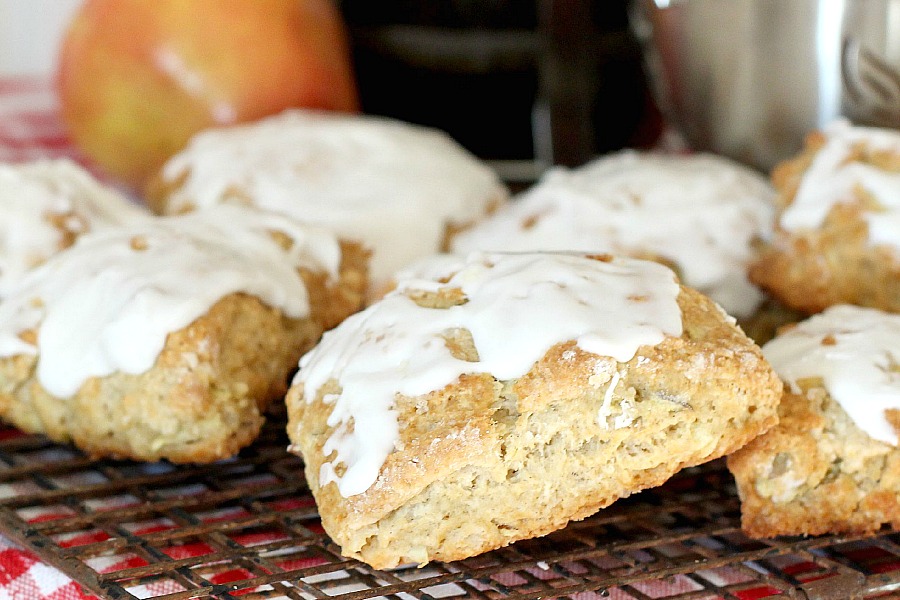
[295,254,681,497]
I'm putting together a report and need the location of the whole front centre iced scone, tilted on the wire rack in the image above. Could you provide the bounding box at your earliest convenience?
[288,253,781,568]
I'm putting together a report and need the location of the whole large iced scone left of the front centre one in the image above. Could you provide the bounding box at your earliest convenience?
[0,206,366,462]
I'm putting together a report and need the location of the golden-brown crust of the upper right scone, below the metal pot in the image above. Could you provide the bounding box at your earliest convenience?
[749,133,900,314]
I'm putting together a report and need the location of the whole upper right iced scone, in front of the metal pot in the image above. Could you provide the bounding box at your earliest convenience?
[750,121,900,314]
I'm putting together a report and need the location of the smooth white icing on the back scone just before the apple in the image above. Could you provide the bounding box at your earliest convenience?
[163,110,506,282]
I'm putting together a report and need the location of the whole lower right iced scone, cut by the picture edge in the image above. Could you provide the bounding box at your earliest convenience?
[728,305,900,537]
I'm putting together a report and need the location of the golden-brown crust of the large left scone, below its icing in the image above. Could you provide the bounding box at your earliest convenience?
[0,244,367,463]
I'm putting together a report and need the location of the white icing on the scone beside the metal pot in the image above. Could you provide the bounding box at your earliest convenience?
[779,120,900,248]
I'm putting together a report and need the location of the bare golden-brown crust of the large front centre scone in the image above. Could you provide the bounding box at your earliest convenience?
[287,288,781,568]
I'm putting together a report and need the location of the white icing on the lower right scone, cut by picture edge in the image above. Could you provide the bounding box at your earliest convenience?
[763,305,900,446]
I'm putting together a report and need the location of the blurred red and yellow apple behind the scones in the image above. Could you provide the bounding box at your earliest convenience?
[56,0,359,189]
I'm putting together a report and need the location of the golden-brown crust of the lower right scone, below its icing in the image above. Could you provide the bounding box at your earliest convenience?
[728,380,900,537]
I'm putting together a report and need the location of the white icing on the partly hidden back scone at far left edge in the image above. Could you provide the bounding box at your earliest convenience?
[0,160,146,298]
